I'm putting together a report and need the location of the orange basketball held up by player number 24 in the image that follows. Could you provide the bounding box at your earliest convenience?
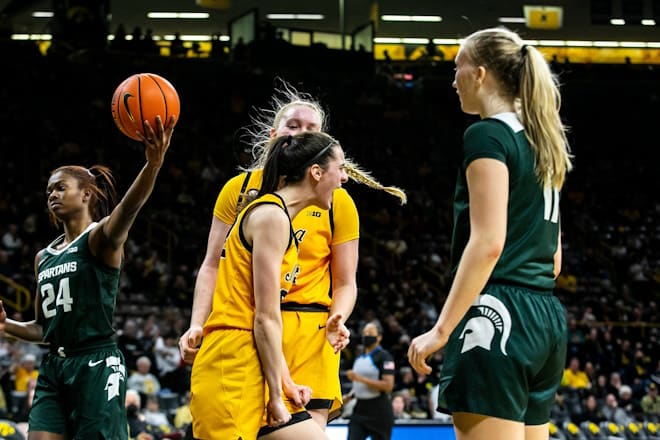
[112,73,181,141]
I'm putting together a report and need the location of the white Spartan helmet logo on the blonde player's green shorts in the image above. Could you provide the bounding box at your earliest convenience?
[459,295,511,356]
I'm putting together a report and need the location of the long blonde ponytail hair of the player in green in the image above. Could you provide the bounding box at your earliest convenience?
[463,28,573,189]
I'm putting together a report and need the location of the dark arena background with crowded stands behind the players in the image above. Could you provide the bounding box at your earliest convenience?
[0,0,660,440]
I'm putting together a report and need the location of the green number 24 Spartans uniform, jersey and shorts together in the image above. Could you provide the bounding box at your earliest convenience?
[29,223,128,440]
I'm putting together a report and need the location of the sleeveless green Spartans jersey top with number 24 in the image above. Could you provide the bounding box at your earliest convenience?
[37,223,119,349]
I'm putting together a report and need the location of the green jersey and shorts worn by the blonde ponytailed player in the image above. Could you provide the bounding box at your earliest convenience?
[438,113,566,425]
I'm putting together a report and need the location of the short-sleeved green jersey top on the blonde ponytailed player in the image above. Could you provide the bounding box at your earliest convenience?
[451,113,559,290]
